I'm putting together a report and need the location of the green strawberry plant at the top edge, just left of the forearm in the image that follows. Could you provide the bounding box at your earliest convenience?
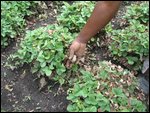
[57,1,94,32]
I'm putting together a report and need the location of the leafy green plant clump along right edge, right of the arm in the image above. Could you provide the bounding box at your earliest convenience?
[106,2,149,70]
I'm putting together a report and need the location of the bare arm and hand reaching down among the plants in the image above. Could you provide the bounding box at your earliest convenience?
[69,1,120,60]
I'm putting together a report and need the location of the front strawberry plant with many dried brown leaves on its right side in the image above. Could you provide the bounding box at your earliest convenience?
[67,61,146,112]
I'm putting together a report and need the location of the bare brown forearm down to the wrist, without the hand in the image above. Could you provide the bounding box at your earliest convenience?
[77,1,120,43]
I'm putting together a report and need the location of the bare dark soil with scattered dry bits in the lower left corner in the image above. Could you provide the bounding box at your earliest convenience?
[1,27,68,112]
